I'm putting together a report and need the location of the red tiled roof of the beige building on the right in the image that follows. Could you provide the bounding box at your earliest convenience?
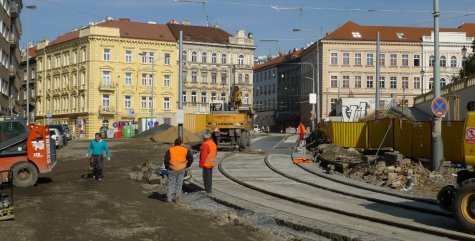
[323,21,475,42]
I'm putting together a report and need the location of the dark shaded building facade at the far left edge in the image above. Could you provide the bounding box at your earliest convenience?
[0,0,23,115]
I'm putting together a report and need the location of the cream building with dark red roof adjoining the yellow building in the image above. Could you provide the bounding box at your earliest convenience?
[167,21,256,113]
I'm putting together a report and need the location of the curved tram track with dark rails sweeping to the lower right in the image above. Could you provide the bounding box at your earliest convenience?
[214,138,474,240]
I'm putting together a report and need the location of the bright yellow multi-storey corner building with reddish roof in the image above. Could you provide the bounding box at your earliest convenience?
[35,18,178,138]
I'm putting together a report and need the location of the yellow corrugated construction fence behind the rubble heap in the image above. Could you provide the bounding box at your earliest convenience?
[323,118,465,163]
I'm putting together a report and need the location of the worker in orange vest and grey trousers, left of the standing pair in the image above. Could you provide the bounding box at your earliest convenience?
[163,137,193,203]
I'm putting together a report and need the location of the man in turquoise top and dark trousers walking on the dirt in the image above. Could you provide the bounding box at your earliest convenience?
[86,133,111,181]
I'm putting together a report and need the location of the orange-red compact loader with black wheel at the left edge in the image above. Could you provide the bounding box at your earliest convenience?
[0,117,56,187]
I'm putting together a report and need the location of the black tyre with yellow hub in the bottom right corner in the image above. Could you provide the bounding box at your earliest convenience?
[454,178,475,234]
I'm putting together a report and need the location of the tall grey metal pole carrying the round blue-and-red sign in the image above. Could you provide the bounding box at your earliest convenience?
[432,0,444,172]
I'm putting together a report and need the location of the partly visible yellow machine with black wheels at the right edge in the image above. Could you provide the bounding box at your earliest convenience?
[437,101,475,234]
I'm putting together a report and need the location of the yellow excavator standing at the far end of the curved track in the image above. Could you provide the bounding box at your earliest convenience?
[206,85,254,150]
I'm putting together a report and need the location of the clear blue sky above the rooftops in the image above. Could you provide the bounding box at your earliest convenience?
[21,0,475,56]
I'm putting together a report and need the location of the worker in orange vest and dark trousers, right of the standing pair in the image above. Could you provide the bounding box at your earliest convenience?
[200,133,218,193]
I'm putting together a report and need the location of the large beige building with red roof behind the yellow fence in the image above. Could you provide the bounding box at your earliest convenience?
[301,22,475,120]
